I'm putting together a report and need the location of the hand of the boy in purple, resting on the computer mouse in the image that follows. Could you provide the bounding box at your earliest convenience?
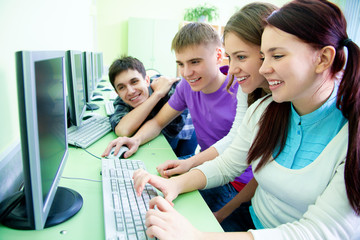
[101,137,140,158]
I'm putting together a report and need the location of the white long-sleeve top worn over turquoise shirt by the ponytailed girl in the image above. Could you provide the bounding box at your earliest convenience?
[197,98,360,240]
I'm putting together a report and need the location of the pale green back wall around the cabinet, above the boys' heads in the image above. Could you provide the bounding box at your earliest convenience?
[97,0,289,71]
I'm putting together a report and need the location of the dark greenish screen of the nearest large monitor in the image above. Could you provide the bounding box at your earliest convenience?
[35,58,67,202]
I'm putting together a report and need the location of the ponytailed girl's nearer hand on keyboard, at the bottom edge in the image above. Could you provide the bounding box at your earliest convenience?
[145,196,205,240]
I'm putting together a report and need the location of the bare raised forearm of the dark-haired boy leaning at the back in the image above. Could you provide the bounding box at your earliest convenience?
[115,94,161,137]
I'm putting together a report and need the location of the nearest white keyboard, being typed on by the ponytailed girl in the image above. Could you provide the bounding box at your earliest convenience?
[102,158,157,240]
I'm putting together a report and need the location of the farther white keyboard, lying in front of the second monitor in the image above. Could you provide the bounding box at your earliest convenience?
[67,115,111,148]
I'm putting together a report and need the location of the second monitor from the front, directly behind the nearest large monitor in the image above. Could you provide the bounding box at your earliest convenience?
[66,50,86,126]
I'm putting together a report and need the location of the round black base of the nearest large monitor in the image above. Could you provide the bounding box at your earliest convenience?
[1,187,83,230]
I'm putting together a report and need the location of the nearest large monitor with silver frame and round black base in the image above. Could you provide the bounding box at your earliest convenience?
[1,51,83,230]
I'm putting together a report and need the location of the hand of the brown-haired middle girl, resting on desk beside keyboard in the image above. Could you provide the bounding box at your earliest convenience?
[156,160,191,178]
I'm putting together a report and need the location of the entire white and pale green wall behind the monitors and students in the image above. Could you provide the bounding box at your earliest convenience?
[0,0,344,158]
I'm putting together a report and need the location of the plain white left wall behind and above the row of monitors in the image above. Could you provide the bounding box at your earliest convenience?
[0,0,96,153]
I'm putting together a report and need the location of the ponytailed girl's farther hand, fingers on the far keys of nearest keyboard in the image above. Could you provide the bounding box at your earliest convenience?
[133,169,179,205]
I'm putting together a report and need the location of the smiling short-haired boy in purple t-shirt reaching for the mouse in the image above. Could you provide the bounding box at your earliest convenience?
[102,23,238,210]
